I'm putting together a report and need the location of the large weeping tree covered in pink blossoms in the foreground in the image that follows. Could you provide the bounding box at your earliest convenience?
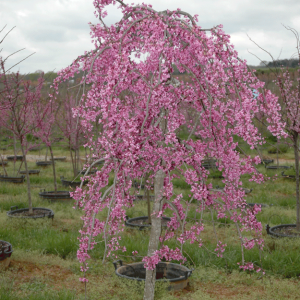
[55,0,283,299]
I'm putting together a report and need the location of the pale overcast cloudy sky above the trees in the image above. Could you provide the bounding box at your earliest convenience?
[0,0,300,73]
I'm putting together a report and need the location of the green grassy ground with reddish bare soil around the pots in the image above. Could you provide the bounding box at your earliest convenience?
[0,142,300,300]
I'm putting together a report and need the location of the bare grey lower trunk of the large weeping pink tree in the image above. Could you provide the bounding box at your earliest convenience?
[144,170,165,300]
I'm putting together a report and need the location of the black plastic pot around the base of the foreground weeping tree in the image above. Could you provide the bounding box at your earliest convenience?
[113,260,193,291]
